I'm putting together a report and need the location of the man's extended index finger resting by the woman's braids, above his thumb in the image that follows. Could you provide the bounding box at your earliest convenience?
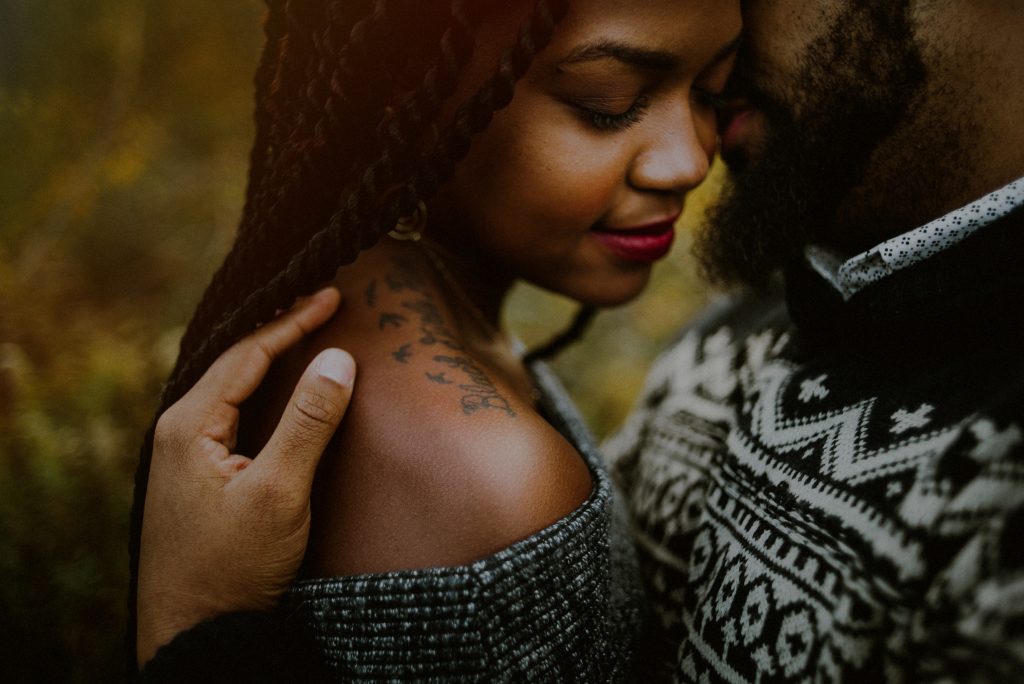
[191,287,341,407]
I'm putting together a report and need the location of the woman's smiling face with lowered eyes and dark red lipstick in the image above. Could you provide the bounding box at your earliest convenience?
[428,0,741,305]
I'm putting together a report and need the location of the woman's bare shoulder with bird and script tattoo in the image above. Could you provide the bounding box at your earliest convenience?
[296,245,593,576]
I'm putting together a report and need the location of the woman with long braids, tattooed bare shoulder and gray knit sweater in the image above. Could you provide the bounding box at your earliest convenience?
[133,0,739,681]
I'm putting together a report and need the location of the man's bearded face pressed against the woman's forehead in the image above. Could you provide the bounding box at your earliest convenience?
[697,0,955,287]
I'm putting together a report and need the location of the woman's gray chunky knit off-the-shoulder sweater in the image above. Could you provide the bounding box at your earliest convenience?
[286,366,643,682]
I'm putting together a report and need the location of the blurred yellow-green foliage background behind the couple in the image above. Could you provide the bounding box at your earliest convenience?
[0,0,715,682]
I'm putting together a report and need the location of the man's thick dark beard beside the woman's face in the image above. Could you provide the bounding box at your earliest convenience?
[696,0,925,290]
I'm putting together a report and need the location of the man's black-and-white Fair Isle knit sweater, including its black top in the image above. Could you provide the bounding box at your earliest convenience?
[605,210,1024,684]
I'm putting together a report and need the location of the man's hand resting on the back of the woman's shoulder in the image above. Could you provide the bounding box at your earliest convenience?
[137,289,355,666]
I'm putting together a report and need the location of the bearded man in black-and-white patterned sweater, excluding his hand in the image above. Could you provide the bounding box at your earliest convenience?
[138,0,1024,682]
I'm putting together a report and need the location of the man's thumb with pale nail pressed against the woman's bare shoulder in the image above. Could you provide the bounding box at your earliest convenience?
[253,349,355,489]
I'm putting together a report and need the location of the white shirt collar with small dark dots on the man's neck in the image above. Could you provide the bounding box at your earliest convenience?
[805,177,1024,300]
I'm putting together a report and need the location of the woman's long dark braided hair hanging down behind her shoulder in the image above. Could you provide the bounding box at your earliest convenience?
[126,0,568,671]
